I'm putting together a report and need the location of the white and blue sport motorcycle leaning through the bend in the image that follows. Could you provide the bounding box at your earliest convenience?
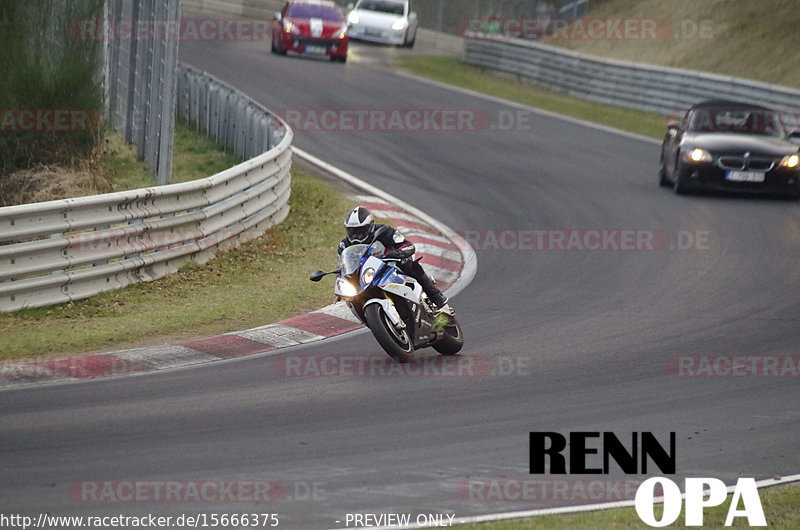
[309,227,464,362]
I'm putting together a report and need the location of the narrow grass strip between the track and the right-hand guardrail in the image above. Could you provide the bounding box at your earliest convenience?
[398,55,667,140]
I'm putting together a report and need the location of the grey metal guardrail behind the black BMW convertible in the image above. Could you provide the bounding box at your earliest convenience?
[464,33,800,118]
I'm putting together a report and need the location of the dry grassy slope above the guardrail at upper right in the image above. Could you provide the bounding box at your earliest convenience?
[546,0,800,87]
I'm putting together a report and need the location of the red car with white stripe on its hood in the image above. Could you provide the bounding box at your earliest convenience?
[272,0,348,62]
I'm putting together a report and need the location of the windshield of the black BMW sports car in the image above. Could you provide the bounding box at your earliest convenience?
[688,108,784,137]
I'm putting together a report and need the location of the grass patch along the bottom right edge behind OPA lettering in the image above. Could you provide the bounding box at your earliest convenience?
[459,485,800,530]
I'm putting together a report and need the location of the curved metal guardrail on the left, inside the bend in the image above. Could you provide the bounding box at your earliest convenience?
[0,65,293,311]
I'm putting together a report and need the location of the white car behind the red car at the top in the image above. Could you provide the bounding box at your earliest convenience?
[347,0,417,48]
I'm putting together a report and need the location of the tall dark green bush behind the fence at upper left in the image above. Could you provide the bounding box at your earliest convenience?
[0,0,103,174]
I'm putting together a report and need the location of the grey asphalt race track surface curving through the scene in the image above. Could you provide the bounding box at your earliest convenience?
[0,36,800,528]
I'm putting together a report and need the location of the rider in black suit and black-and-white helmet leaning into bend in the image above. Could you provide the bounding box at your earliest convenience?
[339,206,453,316]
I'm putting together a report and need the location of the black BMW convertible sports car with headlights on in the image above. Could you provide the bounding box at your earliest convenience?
[659,100,800,199]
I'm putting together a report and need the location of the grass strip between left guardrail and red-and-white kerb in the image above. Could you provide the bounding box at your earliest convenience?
[0,163,352,358]
